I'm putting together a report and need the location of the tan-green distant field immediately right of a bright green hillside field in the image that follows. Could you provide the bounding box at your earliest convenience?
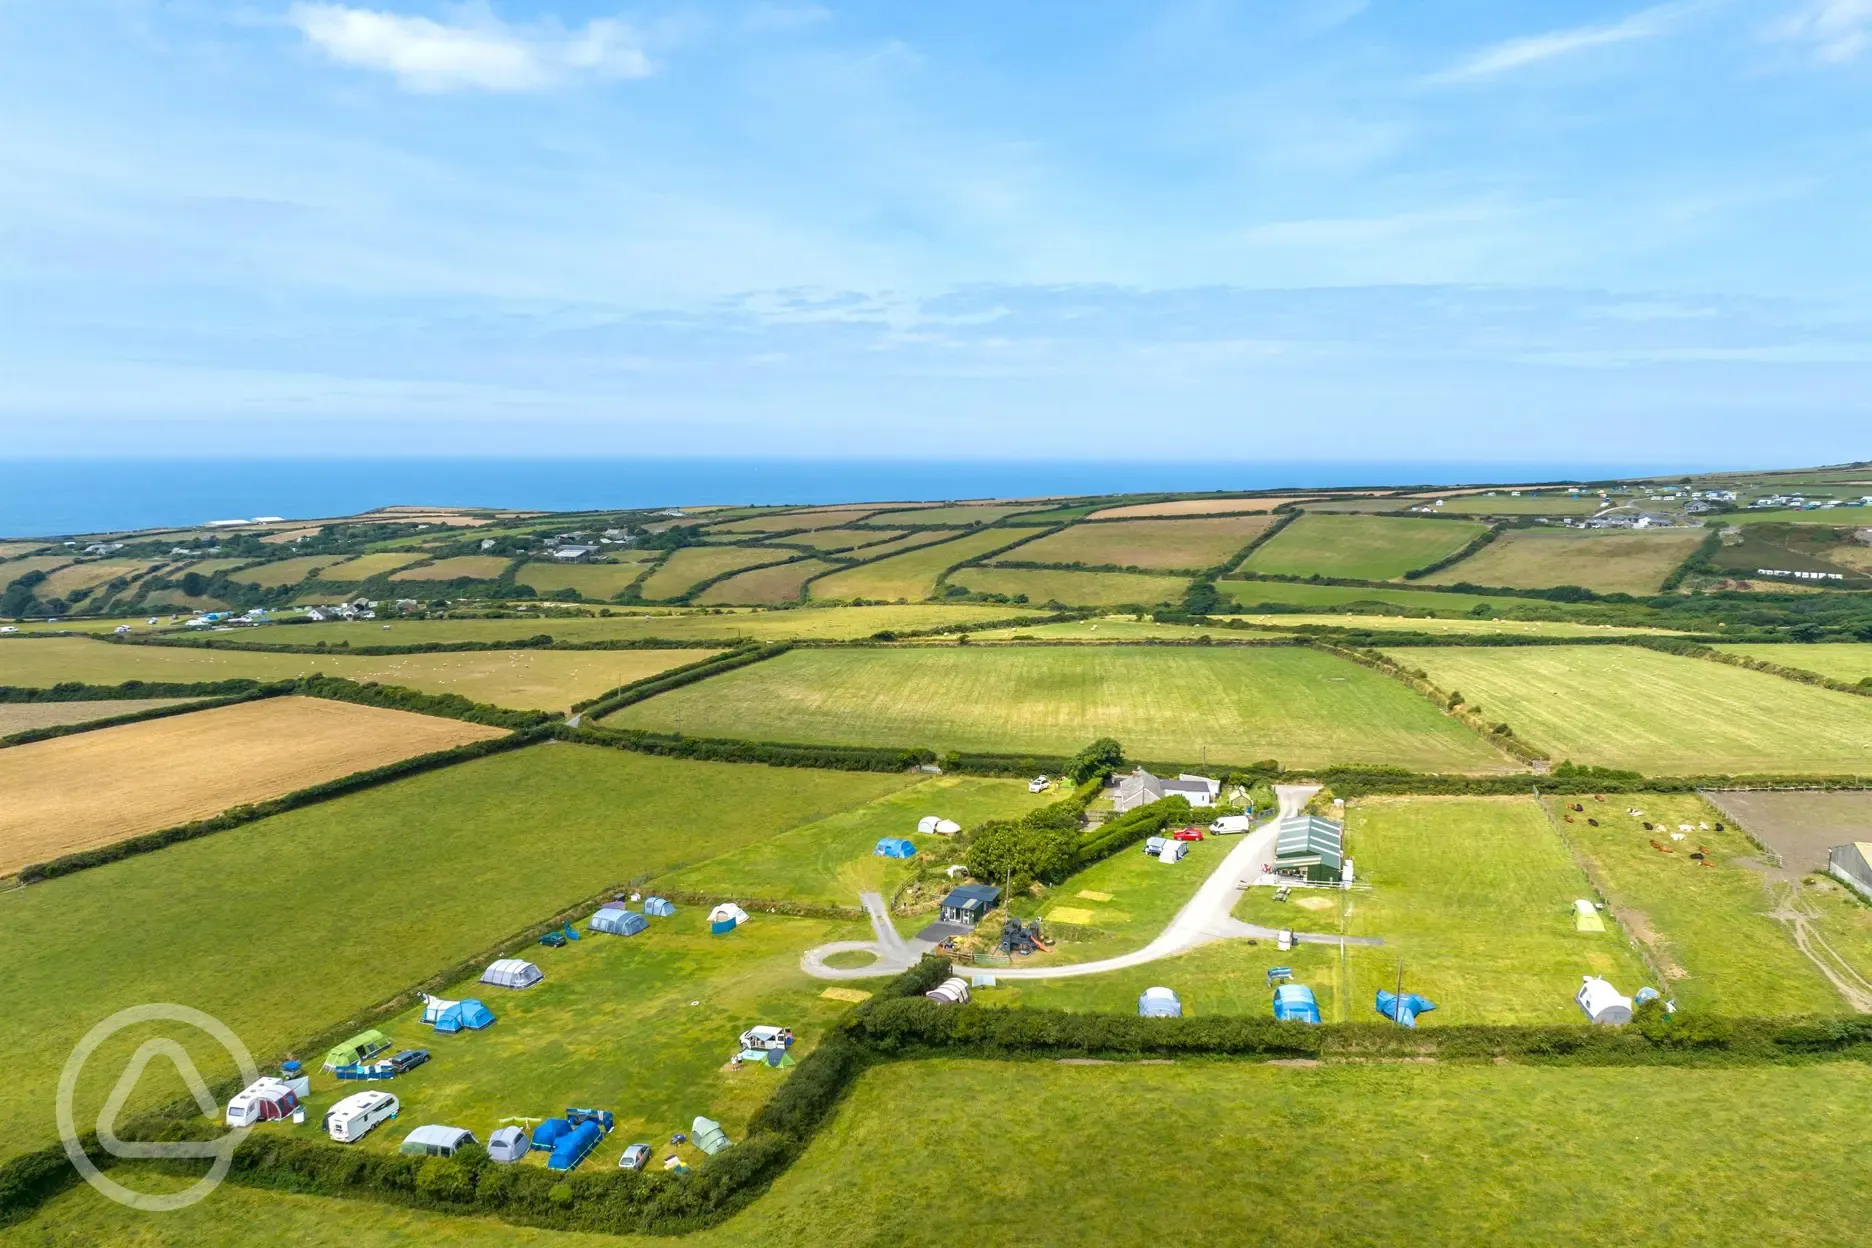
[1430,530,1705,595]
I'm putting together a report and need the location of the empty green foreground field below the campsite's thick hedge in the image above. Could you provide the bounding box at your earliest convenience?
[29,1059,1872,1248]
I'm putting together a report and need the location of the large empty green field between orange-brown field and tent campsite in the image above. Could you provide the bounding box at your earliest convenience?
[0,745,908,1158]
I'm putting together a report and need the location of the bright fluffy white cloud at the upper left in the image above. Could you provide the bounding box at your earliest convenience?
[288,4,650,92]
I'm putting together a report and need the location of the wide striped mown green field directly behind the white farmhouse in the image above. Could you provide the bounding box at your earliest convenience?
[607,646,1512,771]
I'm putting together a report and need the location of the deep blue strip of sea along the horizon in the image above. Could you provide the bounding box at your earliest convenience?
[0,458,1715,537]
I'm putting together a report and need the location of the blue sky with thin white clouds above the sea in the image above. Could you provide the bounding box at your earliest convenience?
[0,0,1872,464]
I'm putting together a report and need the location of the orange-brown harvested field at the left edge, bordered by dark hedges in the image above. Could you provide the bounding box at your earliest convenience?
[0,698,504,885]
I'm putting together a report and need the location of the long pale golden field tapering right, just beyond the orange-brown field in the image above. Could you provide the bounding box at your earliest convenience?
[0,639,715,711]
